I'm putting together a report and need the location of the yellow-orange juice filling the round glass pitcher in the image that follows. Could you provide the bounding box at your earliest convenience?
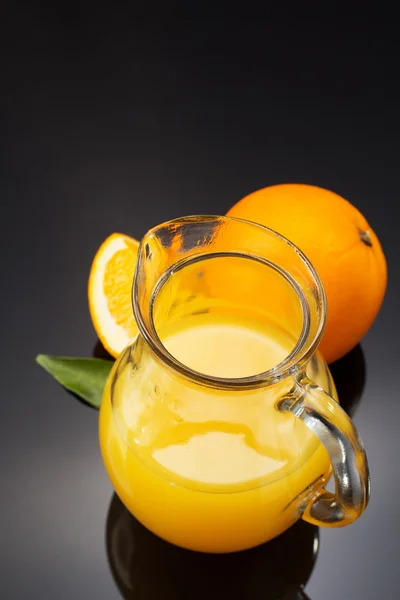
[100,315,329,552]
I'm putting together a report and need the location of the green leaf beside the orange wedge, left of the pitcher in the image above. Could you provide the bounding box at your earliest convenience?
[36,354,114,408]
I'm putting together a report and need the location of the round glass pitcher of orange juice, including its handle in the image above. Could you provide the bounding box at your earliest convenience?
[100,217,369,552]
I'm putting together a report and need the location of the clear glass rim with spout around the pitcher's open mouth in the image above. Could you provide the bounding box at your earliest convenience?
[132,214,327,391]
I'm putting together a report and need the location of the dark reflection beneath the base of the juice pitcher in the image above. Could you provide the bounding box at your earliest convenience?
[106,495,318,600]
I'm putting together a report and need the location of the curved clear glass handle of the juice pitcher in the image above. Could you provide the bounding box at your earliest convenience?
[280,375,370,527]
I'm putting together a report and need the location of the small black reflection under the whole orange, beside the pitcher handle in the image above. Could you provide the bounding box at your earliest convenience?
[329,344,367,417]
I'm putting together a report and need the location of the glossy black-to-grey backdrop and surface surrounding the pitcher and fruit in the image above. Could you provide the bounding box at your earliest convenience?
[0,9,400,600]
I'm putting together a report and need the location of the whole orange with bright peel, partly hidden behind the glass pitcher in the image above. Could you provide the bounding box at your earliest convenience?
[227,184,387,362]
